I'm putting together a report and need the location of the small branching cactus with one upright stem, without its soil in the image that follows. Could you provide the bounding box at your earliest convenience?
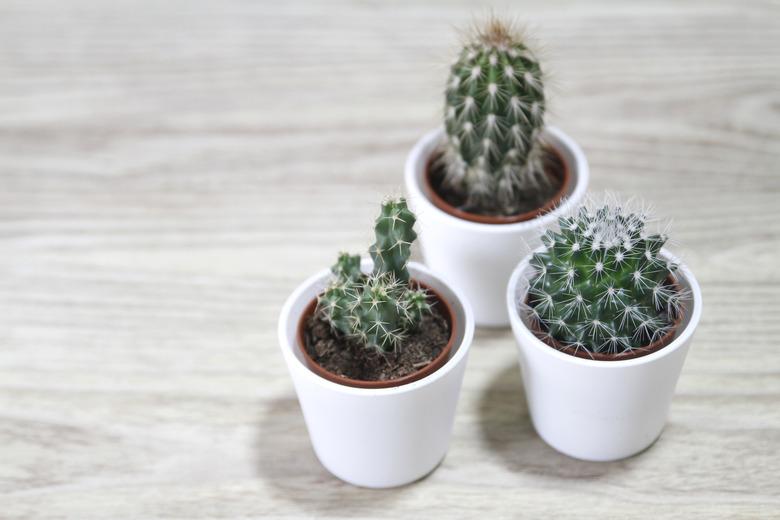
[318,199,431,351]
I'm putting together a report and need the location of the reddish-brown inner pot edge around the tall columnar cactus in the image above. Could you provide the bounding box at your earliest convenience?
[423,146,571,224]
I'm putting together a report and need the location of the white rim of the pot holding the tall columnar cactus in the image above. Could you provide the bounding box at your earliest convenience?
[404,126,590,234]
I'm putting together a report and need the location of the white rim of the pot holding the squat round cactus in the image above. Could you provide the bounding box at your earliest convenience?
[506,246,702,370]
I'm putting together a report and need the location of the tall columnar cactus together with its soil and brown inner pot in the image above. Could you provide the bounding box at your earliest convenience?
[426,19,569,223]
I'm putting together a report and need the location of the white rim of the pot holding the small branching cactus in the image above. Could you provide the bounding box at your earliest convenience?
[277,258,474,396]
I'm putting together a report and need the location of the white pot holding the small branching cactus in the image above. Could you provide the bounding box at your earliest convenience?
[279,260,474,488]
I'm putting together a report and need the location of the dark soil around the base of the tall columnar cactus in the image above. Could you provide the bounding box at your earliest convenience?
[428,149,564,217]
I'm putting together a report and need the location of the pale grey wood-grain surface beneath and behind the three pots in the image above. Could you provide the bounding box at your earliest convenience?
[0,0,780,519]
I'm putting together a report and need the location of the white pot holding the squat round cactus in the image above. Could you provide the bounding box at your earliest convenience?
[505,248,702,461]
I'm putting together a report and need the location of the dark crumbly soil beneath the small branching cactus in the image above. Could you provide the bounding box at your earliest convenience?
[303,306,450,381]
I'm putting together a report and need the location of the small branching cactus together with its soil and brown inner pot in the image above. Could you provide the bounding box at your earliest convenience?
[298,199,456,388]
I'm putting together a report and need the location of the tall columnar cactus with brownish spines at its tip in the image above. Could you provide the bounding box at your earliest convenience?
[445,19,549,215]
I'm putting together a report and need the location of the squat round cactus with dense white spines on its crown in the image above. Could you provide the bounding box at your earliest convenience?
[528,206,684,354]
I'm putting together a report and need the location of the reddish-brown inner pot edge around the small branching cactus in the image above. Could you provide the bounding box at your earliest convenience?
[297,280,457,388]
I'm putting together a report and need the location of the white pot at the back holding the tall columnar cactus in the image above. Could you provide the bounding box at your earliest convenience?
[405,127,588,327]
